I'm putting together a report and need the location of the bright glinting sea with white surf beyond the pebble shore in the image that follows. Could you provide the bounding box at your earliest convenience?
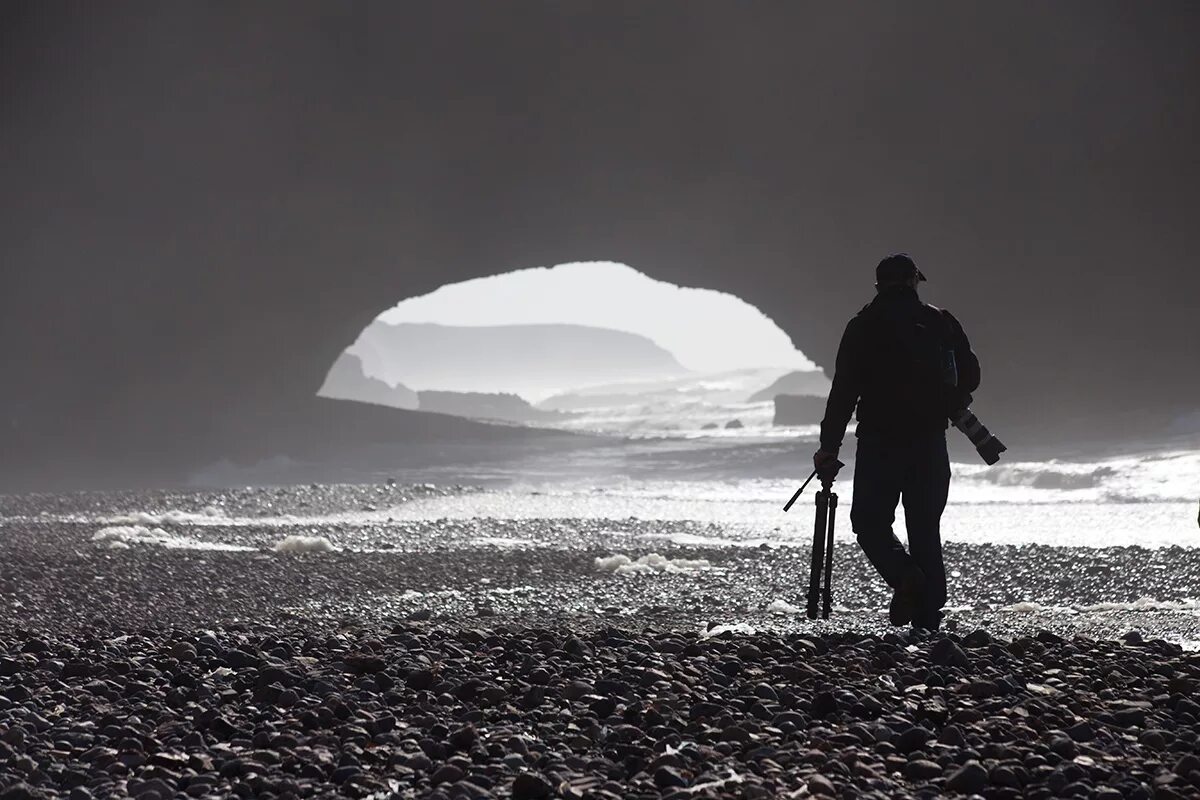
[189,368,1200,548]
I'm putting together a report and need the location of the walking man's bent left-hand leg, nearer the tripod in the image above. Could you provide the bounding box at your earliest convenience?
[850,437,910,589]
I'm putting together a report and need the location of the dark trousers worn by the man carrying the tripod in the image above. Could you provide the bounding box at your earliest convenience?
[850,431,950,628]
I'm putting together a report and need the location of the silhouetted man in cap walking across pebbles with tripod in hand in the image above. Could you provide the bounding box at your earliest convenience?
[812,254,979,630]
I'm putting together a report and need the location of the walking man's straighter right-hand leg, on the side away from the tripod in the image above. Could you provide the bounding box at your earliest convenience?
[904,435,950,630]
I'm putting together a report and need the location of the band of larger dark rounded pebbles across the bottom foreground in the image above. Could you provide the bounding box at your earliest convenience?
[0,624,1200,800]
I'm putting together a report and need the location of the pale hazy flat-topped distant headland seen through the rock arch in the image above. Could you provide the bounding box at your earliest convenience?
[349,321,686,397]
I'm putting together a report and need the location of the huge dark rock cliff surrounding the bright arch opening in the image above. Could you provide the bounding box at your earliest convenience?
[0,0,1200,484]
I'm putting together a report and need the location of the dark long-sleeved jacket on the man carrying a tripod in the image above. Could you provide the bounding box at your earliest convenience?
[821,287,979,452]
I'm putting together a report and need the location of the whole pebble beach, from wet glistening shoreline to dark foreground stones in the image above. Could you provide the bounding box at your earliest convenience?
[0,483,1200,800]
